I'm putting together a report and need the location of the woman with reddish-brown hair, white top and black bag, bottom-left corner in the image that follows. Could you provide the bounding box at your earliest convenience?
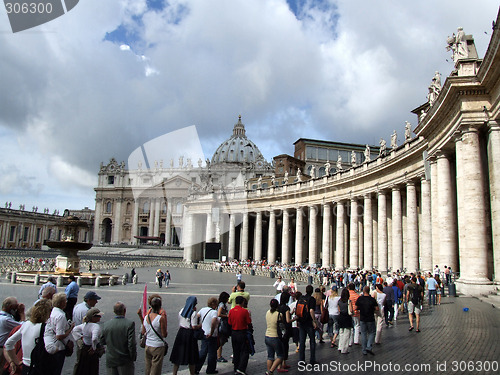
[4,299,52,375]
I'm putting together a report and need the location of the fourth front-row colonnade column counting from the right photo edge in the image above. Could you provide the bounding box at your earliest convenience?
[420,176,433,272]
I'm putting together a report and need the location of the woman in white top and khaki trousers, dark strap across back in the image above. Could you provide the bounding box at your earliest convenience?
[142,295,167,375]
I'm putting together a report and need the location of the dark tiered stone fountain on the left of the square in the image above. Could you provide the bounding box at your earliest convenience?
[47,216,92,276]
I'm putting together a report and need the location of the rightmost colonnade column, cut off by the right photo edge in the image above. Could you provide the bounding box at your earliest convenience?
[487,121,500,284]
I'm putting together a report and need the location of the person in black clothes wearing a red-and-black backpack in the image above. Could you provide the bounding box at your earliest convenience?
[295,285,318,364]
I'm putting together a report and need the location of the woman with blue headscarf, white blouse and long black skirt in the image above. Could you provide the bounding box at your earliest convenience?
[170,296,201,375]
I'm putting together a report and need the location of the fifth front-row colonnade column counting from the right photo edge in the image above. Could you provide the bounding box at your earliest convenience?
[405,181,420,272]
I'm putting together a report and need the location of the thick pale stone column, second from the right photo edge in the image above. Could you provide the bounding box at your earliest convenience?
[452,126,491,285]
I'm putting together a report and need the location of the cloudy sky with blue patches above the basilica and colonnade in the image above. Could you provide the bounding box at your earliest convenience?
[0,0,498,212]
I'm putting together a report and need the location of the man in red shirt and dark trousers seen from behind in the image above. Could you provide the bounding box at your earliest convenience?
[228,296,252,375]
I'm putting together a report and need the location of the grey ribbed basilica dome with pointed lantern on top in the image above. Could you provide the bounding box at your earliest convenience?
[212,115,268,168]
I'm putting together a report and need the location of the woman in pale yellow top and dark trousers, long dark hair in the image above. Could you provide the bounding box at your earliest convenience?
[265,298,288,375]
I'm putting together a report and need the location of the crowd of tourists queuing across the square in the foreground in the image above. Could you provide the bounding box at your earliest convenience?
[0,266,450,375]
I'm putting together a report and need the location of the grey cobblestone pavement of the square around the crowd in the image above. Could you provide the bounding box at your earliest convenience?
[0,268,500,375]
